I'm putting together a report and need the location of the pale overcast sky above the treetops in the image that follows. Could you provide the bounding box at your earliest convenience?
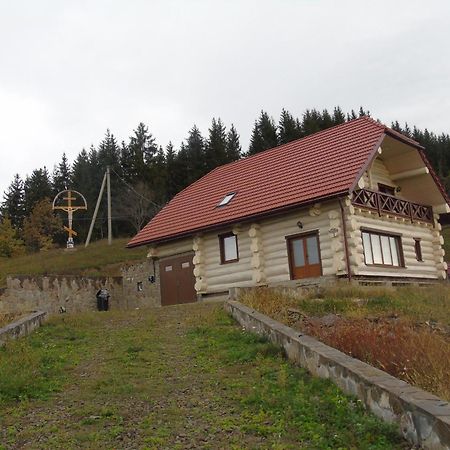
[0,0,450,196]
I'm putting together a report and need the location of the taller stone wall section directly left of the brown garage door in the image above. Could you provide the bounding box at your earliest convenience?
[122,258,161,308]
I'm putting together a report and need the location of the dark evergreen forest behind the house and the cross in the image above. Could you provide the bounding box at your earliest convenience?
[0,107,450,257]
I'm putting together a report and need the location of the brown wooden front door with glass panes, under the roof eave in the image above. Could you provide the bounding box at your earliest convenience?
[288,233,322,280]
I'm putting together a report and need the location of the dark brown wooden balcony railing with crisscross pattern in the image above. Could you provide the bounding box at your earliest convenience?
[352,189,433,223]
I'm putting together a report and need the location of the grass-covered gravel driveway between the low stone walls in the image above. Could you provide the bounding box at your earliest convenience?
[0,304,409,449]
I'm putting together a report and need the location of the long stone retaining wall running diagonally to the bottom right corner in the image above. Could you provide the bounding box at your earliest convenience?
[225,301,450,450]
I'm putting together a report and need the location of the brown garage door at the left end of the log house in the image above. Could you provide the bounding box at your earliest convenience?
[159,254,197,306]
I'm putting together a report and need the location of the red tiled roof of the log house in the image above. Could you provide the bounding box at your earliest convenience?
[127,117,420,247]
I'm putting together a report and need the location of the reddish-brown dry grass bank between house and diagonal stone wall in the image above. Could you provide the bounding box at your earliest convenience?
[240,285,450,400]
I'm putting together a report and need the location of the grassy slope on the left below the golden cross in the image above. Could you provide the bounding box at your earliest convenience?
[0,239,146,287]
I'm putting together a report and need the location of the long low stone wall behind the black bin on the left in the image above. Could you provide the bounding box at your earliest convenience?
[0,275,123,313]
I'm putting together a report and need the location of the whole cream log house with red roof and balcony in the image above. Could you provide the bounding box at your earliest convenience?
[128,117,450,305]
